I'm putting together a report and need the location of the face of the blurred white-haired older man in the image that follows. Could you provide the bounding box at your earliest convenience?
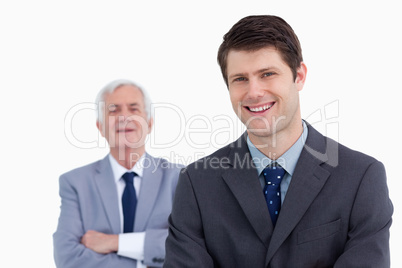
[97,85,152,149]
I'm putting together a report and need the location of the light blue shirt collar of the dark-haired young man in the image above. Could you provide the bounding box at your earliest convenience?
[247,121,308,176]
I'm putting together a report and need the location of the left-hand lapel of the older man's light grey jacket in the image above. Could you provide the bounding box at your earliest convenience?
[95,156,121,234]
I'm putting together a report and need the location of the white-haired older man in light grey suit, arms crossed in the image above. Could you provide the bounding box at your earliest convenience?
[53,80,182,268]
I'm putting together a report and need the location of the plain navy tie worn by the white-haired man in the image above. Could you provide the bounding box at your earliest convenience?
[122,172,137,233]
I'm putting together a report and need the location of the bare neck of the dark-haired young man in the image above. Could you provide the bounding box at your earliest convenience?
[247,121,303,160]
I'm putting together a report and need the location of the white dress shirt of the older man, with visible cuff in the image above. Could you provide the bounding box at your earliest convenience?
[109,154,146,268]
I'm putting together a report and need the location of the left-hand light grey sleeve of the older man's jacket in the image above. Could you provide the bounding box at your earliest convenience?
[53,176,126,268]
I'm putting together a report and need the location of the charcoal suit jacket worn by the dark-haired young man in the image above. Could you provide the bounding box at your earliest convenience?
[164,126,393,268]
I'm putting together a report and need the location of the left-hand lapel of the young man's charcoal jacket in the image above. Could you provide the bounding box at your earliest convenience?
[222,135,273,248]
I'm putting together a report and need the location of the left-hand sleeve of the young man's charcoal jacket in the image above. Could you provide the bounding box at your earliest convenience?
[164,170,214,268]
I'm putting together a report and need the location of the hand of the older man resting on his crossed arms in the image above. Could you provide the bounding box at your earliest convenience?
[81,230,119,254]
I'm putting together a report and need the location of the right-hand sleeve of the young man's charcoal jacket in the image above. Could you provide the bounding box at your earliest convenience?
[334,162,393,268]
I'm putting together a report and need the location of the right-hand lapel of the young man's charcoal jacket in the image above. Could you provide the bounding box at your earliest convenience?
[266,126,330,265]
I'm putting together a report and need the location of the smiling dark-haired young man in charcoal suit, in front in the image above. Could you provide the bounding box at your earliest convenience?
[164,16,393,268]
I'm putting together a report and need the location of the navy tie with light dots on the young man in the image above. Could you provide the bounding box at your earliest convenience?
[263,163,285,226]
